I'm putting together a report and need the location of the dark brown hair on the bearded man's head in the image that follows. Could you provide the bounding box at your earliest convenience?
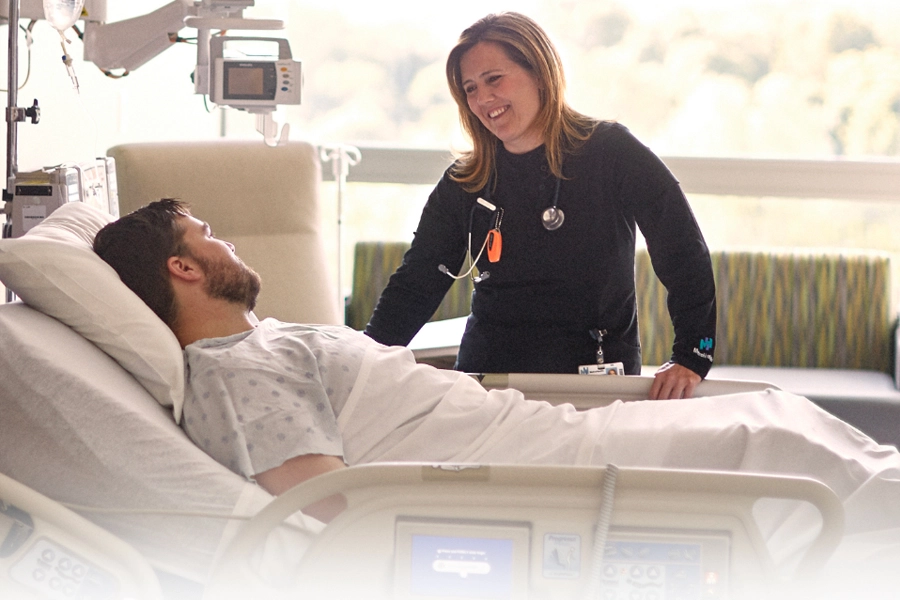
[94,198,191,327]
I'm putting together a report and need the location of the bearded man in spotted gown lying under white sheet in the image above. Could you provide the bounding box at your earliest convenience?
[94,200,900,544]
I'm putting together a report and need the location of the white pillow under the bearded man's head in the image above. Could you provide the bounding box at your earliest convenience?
[0,202,184,422]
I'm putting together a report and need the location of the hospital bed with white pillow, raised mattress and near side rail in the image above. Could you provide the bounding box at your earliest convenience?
[0,142,888,600]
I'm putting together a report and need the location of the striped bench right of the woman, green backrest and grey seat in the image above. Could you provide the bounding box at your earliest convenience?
[635,250,900,447]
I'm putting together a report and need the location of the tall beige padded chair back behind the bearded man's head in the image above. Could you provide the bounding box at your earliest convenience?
[107,140,343,324]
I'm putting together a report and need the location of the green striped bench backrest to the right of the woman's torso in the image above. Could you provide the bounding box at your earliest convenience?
[635,250,896,373]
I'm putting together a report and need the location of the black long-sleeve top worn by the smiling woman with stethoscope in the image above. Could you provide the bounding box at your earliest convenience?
[366,123,716,377]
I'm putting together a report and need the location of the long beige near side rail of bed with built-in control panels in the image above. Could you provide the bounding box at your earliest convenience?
[208,463,843,600]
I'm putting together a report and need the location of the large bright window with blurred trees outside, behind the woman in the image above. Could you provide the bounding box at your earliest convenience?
[1,0,900,300]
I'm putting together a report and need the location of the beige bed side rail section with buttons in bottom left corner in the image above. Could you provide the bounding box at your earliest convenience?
[0,473,161,600]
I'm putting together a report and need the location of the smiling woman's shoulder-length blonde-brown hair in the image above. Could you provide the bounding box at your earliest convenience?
[447,12,598,192]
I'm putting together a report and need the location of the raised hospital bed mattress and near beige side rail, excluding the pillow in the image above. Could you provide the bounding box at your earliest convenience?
[0,303,842,600]
